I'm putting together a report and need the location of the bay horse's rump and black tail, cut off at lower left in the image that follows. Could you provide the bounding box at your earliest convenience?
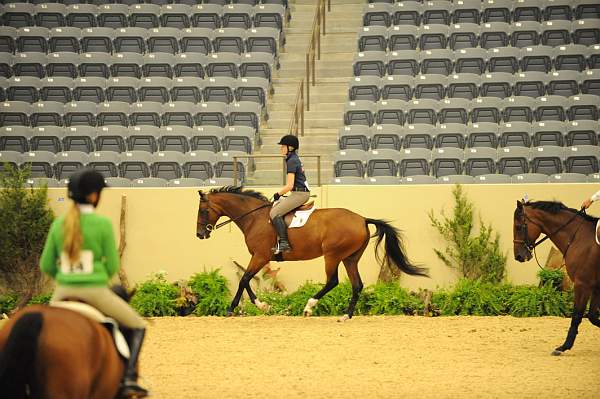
[0,288,134,399]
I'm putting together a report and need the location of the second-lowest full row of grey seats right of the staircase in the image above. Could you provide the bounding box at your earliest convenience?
[338,121,600,151]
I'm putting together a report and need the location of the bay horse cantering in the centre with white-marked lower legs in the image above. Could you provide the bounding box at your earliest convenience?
[196,186,427,321]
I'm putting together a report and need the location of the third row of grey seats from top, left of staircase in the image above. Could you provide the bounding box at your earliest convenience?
[0,52,278,80]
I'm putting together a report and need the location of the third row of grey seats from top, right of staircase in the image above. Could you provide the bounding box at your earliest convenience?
[352,44,600,77]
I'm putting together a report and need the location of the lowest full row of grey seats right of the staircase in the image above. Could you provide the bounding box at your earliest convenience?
[333,146,600,177]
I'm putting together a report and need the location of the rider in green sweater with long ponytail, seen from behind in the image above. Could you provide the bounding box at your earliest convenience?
[40,169,148,397]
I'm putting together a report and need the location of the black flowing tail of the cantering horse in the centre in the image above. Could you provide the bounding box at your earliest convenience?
[365,218,429,277]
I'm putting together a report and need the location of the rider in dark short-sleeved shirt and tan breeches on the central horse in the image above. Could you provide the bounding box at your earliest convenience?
[269,134,310,254]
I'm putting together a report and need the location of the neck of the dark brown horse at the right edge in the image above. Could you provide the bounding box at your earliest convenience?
[529,209,586,254]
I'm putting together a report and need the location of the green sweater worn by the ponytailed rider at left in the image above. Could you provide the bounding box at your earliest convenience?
[40,213,119,286]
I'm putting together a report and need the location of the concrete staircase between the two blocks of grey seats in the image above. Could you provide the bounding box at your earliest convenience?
[246,0,366,186]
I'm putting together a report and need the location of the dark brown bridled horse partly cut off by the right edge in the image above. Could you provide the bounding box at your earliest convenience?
[513,201,600,355]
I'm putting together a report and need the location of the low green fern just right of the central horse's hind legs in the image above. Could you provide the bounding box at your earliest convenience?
[363,282,424,315]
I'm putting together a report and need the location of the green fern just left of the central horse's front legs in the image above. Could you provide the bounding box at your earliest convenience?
[189,269,231,316]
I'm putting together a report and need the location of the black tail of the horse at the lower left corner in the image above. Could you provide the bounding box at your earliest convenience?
[0,312,44,399]
